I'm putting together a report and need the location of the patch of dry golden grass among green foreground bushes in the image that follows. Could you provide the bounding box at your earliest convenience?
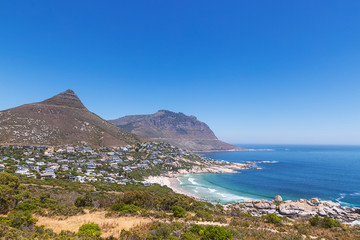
[35,212,152,237]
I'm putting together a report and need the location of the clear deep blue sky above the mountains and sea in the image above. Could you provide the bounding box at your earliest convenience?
[0,0,360,144]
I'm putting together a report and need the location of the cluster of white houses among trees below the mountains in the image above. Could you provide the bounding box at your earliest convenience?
[0,142,221,185]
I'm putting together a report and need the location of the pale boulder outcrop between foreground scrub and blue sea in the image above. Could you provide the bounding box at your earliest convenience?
[227,198,360,222]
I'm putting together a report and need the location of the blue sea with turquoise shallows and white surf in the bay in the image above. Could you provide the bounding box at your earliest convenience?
[179,145,360,207]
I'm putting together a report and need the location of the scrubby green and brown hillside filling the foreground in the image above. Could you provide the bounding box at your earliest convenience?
[0,172,360,240]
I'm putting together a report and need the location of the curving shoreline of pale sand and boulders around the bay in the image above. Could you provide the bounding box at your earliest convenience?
[145,161,360,225]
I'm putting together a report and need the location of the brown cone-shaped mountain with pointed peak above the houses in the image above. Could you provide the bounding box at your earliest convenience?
[0,90,146,147]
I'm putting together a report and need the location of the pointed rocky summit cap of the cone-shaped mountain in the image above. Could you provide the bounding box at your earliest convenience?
[41,89,86,109]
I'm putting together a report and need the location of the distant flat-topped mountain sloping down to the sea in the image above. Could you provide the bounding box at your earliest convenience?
[109,110,242,152]
